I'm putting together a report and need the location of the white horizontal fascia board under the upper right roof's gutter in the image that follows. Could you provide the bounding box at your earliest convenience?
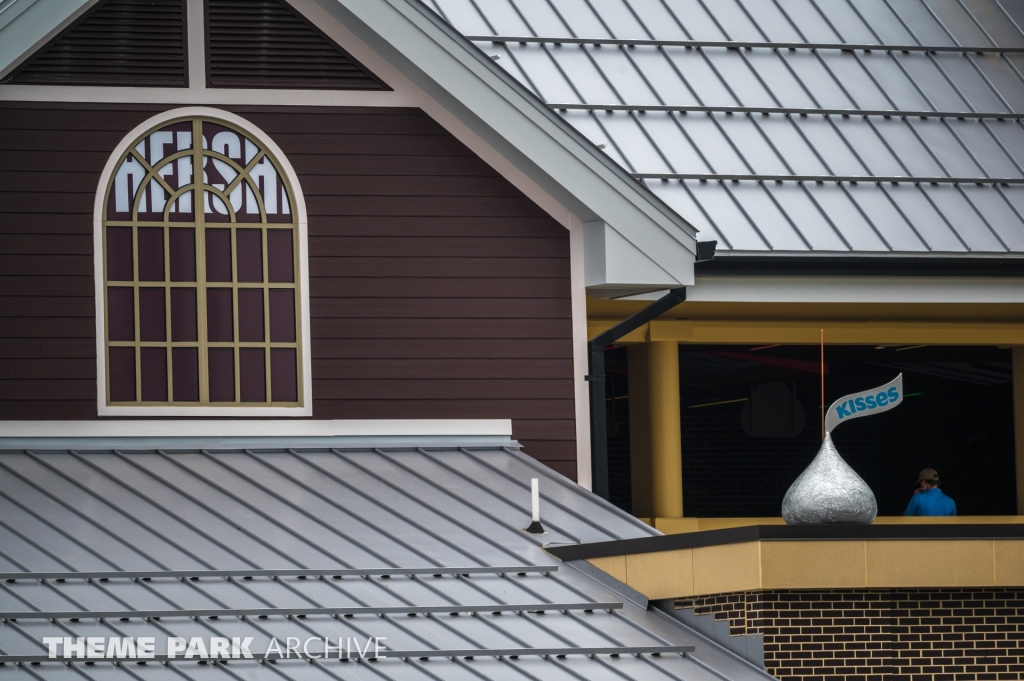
[630,274,1024,304]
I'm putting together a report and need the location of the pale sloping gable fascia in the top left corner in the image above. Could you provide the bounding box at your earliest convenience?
[0,0,97,78]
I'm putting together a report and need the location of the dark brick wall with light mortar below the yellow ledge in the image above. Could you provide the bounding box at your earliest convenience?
[676,589,1024,681]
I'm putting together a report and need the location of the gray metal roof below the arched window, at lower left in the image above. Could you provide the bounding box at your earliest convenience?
[0,448,767,681]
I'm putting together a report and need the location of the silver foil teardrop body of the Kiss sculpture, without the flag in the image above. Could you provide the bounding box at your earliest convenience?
[782,432,879,525]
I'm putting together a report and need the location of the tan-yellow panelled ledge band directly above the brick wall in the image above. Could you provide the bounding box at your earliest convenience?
[588,539,1024,599]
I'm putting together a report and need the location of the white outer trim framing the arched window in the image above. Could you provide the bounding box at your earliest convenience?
[92,107,313,417]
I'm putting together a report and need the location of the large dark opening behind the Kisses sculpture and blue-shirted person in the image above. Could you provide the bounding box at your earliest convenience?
[679,345,1017,517]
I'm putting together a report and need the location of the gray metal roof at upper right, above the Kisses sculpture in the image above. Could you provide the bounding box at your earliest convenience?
[434,0,1024,256]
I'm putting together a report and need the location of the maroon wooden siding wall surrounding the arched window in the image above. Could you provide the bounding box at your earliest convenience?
[0,103,575,477]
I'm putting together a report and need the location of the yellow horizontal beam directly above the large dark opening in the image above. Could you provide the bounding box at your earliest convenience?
[587,320,1024,346]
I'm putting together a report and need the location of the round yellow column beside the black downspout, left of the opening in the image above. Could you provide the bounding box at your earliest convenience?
[647,341,683,518]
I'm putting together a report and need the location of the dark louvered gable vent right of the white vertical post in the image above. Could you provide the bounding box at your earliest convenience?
[207,0,390,90]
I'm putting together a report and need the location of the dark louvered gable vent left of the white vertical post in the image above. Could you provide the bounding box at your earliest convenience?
[4,0,187,87]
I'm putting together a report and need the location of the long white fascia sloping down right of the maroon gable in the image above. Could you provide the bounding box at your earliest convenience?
[316,0,696,285]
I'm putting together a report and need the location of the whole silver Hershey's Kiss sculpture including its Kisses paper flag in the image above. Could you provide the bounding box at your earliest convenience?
[782,374,903,525]
